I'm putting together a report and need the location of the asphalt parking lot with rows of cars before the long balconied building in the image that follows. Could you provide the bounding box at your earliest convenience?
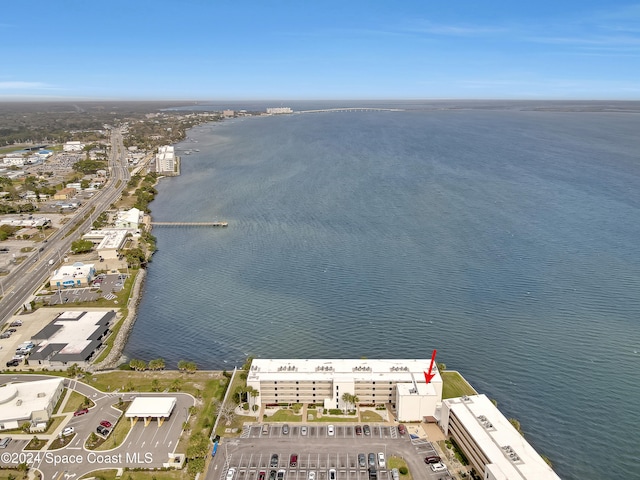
[210,423,448,480]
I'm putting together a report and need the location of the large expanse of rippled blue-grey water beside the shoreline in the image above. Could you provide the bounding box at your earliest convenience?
[125,103,640,480]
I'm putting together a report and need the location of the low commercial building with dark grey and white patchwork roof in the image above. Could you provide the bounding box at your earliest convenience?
[28,310,116,367]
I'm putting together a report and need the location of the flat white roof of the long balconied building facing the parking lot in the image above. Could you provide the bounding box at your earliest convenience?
[248,359,442,383]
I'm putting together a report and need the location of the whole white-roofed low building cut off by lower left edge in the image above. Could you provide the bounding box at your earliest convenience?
[0,378,64,431]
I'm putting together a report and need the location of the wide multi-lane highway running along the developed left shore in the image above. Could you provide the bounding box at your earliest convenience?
[0,128,130,325]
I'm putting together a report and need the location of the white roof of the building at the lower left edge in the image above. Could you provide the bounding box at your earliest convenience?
[0,378,63,422]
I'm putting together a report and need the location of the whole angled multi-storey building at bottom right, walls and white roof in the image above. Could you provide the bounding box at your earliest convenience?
[440,395,560,480]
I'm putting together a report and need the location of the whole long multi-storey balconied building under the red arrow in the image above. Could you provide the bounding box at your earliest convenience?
[247,359,442,422]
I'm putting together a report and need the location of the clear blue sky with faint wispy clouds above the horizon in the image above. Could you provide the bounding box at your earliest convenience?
[0,0,640,100]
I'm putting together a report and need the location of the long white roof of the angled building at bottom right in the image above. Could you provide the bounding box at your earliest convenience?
[445,395,560,480]
